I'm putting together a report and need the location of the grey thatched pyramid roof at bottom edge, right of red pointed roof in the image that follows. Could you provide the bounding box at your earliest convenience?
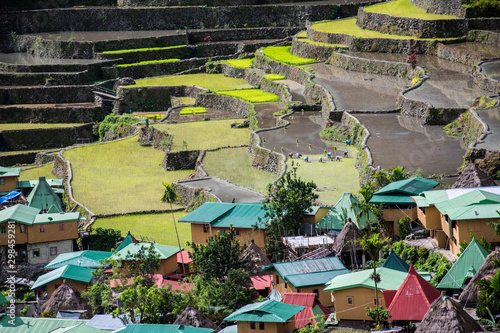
[415,296,482,333]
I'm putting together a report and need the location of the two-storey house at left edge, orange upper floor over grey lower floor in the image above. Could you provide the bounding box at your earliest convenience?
[0,205,81,264]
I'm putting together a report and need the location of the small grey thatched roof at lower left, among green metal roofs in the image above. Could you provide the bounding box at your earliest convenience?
[42,280,91,318]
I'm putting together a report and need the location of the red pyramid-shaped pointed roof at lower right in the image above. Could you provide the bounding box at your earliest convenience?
[387,265,440,320]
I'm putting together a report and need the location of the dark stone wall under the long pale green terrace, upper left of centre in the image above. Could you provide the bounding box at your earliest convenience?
[118,86,205,111]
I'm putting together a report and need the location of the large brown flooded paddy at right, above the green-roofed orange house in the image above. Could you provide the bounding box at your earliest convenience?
[354,114,465,176]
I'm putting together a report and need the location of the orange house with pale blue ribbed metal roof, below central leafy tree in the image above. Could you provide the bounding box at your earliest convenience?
[263,257,350,307]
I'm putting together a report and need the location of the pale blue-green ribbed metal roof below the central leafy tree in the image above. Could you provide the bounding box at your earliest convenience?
[263,257,350,288]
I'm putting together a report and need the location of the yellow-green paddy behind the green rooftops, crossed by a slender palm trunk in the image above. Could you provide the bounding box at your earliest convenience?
[92,213,191,250]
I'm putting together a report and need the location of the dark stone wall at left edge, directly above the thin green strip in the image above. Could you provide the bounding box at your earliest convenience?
[0,105,106,124]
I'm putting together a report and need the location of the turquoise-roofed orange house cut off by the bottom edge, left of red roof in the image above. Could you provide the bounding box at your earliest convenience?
[224,300,305,333]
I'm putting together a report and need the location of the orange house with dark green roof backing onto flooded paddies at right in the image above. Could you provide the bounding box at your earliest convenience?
[370,177,439,237]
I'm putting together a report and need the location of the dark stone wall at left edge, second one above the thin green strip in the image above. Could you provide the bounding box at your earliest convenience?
[0,86,94,105]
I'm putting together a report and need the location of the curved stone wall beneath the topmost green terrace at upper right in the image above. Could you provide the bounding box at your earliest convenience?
[356,8,468,38]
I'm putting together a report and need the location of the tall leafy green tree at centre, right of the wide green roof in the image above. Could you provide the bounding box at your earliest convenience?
[264,164,318,259]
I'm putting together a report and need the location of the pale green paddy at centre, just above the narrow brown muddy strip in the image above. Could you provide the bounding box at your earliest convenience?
[203,148,278,194]
